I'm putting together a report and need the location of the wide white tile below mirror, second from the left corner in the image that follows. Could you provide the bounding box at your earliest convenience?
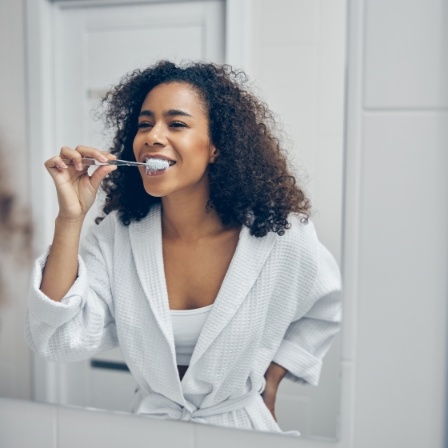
[58,407,194,448]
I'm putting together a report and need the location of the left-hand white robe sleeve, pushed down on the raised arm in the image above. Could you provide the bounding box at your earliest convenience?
[25,219,118,362]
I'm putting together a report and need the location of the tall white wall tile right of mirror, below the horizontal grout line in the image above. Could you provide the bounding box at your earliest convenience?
[355,113,448,448]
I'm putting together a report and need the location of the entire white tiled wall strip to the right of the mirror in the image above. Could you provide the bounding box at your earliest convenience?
[352,0,448,448]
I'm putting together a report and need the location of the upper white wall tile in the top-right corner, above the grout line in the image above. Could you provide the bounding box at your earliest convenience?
[364,0,448,108]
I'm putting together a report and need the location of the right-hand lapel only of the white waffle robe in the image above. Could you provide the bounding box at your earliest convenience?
[187,227,276,366]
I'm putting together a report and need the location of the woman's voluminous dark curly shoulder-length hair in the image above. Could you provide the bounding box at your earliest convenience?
[97,61,310,237]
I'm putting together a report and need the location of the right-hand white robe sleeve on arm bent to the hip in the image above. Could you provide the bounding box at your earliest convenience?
[273,234,341,385]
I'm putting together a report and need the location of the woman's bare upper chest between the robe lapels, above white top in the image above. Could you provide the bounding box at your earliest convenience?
[163,231,238,309]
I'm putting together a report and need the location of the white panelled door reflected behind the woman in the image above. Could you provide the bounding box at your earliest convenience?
[53,0,225,411]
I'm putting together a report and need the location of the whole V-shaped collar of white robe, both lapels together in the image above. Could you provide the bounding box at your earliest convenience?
[129,205,276,372]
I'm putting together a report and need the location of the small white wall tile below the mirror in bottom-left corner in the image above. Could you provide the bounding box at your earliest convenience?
[0,398,57,448]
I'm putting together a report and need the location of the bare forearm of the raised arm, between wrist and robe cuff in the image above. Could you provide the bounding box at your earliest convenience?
[40,217,83,302]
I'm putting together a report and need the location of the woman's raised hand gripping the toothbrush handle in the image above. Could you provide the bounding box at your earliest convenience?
[45,146,117,220]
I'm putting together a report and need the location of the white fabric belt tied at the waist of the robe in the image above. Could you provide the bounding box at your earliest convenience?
[137,389,258,423]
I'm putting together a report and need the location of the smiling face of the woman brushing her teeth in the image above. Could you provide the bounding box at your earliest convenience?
[134,82,216,197]
